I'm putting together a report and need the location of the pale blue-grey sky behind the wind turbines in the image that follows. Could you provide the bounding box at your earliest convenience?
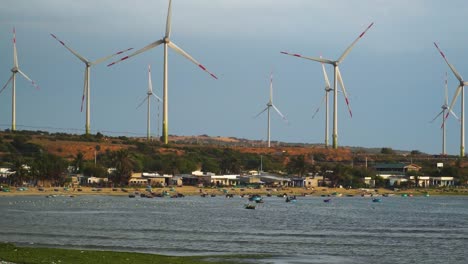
[0,0,468,154]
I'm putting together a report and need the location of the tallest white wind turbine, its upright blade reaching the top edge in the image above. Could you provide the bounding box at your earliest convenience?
[107,0,218,144]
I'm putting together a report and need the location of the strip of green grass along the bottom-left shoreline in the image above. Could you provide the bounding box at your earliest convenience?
[0,243,268,264]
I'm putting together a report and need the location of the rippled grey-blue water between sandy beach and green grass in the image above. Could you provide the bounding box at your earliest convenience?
[0,196,468,263]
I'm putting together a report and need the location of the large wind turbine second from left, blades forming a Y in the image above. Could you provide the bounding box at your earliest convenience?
[50,34,133,135]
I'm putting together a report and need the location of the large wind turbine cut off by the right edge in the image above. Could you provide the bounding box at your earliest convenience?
[434,42,468,157]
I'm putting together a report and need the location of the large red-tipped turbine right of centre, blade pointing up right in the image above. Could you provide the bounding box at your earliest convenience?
[281,23,374,149]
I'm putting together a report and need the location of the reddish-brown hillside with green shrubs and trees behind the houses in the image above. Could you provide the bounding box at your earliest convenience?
[0,131,468,187]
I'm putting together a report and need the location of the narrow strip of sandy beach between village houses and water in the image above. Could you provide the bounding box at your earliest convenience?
[0,186,468,196]
